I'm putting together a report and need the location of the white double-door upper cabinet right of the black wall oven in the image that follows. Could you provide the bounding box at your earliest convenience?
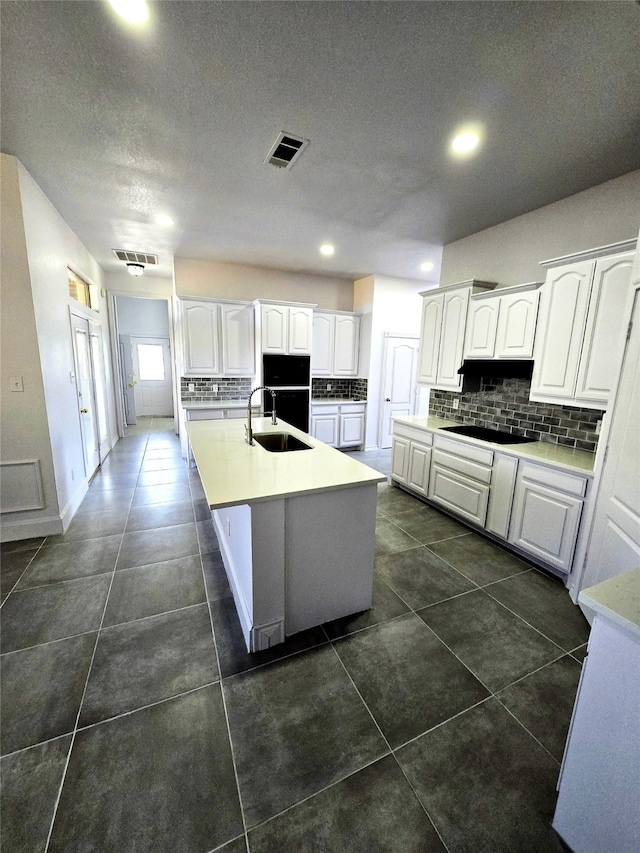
[311,311,360,376]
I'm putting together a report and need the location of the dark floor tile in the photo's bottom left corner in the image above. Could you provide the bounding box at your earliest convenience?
[0,735,71,853]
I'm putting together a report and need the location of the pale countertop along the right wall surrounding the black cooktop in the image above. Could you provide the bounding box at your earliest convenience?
[393,415,596,476]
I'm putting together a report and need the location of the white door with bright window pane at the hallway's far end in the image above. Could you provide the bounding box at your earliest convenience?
[131,335,173,417]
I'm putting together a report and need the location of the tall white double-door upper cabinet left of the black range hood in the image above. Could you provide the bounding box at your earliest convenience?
[418,279,496,391]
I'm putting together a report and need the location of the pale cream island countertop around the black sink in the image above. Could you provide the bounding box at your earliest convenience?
[187,417,387,509]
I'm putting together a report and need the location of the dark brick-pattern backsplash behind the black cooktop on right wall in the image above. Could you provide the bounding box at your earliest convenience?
[429,378,604,453]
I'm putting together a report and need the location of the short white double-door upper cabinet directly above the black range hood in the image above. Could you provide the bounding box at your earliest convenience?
[464,281,542,359]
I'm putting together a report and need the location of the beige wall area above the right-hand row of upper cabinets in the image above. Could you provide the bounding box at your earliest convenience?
[440,170,640,285]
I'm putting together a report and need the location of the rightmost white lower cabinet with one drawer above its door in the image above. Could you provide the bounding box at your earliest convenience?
[509,462,587,572]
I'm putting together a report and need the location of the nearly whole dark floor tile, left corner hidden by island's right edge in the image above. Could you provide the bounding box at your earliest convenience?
[375,547,476,610]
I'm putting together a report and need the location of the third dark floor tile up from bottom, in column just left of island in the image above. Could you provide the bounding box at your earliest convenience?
[104,555,206,626]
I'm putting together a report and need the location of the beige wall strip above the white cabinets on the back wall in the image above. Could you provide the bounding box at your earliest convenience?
[174,258,353,311]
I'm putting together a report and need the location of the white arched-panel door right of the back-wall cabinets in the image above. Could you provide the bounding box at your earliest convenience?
[380,335,419,447]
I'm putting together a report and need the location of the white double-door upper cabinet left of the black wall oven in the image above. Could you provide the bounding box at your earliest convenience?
[180,299,255,376]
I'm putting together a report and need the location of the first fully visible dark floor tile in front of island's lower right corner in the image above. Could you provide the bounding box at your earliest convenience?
[335,614,489,748]
